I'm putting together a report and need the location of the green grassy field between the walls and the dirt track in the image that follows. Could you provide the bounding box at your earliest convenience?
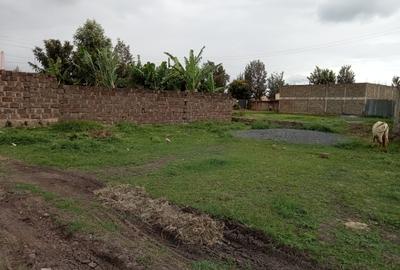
[0,112,400,269]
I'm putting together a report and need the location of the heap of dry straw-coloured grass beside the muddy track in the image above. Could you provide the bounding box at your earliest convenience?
[95,185,223,246]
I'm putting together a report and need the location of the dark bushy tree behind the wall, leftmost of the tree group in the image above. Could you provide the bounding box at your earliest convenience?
[28,39,74,84]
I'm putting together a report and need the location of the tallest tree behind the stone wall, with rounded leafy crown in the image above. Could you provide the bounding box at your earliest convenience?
[73,20,112,85]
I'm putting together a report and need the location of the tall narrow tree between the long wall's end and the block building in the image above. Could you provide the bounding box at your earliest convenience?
[244,60,267,100]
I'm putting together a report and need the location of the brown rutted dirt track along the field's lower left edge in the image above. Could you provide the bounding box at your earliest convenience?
[0,157,319,270]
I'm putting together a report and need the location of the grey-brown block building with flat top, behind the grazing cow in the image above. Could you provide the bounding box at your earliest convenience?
[279,83,396,116]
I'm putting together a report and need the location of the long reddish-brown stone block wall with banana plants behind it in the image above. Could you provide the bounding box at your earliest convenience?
[0,71,233,126]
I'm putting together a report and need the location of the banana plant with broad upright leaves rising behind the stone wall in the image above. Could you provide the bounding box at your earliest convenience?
[165,47,215,92]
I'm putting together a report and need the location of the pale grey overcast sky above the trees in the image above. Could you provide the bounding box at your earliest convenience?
[0,0,400,84]
